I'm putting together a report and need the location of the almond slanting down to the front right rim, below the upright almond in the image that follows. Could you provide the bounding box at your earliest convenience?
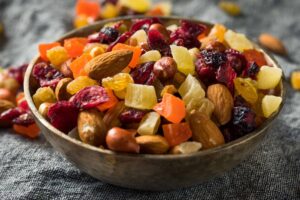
[189,111,225,149]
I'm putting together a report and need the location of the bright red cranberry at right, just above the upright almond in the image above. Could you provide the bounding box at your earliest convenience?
[216,63,237,94]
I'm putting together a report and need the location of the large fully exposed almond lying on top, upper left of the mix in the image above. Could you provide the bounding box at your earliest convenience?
[84,50,133,80]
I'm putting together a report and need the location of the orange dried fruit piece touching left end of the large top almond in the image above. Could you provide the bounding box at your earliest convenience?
[70,54,92,78]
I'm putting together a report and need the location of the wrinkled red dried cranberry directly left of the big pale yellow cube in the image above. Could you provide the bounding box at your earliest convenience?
[70,86,109,109]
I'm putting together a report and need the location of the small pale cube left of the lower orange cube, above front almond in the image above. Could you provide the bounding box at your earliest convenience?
[137,112,161,135]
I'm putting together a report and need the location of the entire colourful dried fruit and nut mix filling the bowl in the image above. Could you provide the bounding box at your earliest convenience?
[32,18,282,154]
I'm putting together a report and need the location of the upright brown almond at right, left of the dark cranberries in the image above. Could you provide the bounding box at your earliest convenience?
[207,84,233,125]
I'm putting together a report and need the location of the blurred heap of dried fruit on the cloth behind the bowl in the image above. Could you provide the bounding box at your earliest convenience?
[74,0,172,28]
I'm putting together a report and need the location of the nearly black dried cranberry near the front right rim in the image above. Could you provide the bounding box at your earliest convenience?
[232,106,256,136]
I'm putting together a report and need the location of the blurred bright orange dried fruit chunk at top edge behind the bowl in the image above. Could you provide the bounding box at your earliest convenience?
[75,0,101,19]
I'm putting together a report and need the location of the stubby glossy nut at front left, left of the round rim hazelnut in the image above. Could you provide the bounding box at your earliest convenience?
[77,109,107,146]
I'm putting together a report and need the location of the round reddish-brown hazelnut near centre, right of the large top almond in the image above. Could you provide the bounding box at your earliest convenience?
[153,57,177,81]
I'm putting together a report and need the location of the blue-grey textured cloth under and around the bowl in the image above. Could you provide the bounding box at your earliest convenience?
[0,0,300,200]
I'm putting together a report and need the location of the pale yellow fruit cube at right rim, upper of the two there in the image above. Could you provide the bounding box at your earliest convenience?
[257,65,282,90]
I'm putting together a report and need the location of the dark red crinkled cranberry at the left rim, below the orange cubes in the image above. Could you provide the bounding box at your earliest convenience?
[32,62,63,88]
